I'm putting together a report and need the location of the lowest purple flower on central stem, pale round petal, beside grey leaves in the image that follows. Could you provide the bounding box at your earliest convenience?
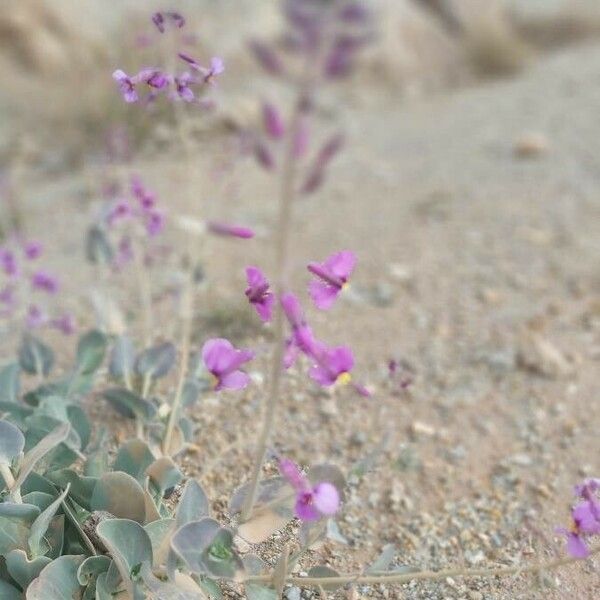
[279,458,340,521]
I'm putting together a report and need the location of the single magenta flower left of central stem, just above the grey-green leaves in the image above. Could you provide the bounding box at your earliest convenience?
[202,338,254,391]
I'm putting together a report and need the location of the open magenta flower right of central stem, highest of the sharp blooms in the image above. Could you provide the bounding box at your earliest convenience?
[308,250,356,310]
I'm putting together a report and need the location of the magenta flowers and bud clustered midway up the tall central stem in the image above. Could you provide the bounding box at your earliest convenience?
[246,250,369,396]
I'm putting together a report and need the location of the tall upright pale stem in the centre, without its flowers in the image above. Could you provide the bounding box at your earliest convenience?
[241,97,303,522]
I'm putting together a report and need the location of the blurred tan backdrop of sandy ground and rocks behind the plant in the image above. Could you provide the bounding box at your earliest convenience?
[0,0,600,600]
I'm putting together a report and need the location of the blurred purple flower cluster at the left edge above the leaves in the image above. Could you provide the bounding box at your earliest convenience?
[0,238,75,335]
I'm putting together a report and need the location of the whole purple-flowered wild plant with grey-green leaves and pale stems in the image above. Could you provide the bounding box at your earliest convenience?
[0,0,600,600]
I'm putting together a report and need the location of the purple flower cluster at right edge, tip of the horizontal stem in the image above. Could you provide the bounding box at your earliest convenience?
[557,479,600,558]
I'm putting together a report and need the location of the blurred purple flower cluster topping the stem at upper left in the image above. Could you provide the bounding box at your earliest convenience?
[113,12,225,104]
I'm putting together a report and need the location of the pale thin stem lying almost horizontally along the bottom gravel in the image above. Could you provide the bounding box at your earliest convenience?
[247,546,600,587]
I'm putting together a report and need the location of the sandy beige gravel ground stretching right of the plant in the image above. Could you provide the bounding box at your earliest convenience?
[8,36,600,600]
